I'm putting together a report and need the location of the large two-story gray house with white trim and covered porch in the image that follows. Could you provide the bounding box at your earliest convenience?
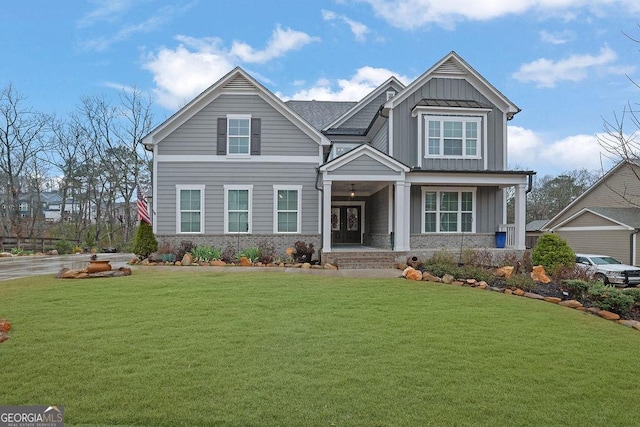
[142,52,535,261]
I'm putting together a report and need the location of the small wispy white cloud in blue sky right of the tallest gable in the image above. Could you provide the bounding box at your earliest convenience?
[513,47,617,87]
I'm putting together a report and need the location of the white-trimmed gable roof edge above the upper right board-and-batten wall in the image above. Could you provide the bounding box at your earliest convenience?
[385,51,520,119]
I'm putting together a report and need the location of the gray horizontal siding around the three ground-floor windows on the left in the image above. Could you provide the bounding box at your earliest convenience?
[156,162,319,235]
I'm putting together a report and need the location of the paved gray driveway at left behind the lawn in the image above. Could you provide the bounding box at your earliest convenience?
[0,254,135,281]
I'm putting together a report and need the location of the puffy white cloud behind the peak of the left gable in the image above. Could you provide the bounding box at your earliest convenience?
[143,26,317,109]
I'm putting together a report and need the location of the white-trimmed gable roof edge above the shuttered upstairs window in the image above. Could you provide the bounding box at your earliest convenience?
[142,67,329,147]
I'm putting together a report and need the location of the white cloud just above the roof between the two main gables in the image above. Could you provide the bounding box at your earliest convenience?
[279,66,409,101]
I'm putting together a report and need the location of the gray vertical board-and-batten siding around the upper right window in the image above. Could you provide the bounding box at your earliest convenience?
[393,78,505,171]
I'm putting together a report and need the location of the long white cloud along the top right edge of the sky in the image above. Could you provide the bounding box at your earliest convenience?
[360,0,640,29]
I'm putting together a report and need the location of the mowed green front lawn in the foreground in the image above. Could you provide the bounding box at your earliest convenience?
[0,268,640,426]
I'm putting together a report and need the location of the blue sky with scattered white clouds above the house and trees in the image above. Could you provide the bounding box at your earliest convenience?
[0,0,640,176]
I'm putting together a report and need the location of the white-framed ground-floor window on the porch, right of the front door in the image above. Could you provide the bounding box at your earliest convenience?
[422,188,475,233]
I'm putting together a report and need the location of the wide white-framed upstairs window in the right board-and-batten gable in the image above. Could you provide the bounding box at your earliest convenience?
[424,115,482,158]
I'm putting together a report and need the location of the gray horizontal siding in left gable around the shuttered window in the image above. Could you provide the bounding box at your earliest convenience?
[158,95,318,156]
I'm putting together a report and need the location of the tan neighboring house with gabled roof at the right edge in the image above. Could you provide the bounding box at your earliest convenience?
[542,161,640,266]
